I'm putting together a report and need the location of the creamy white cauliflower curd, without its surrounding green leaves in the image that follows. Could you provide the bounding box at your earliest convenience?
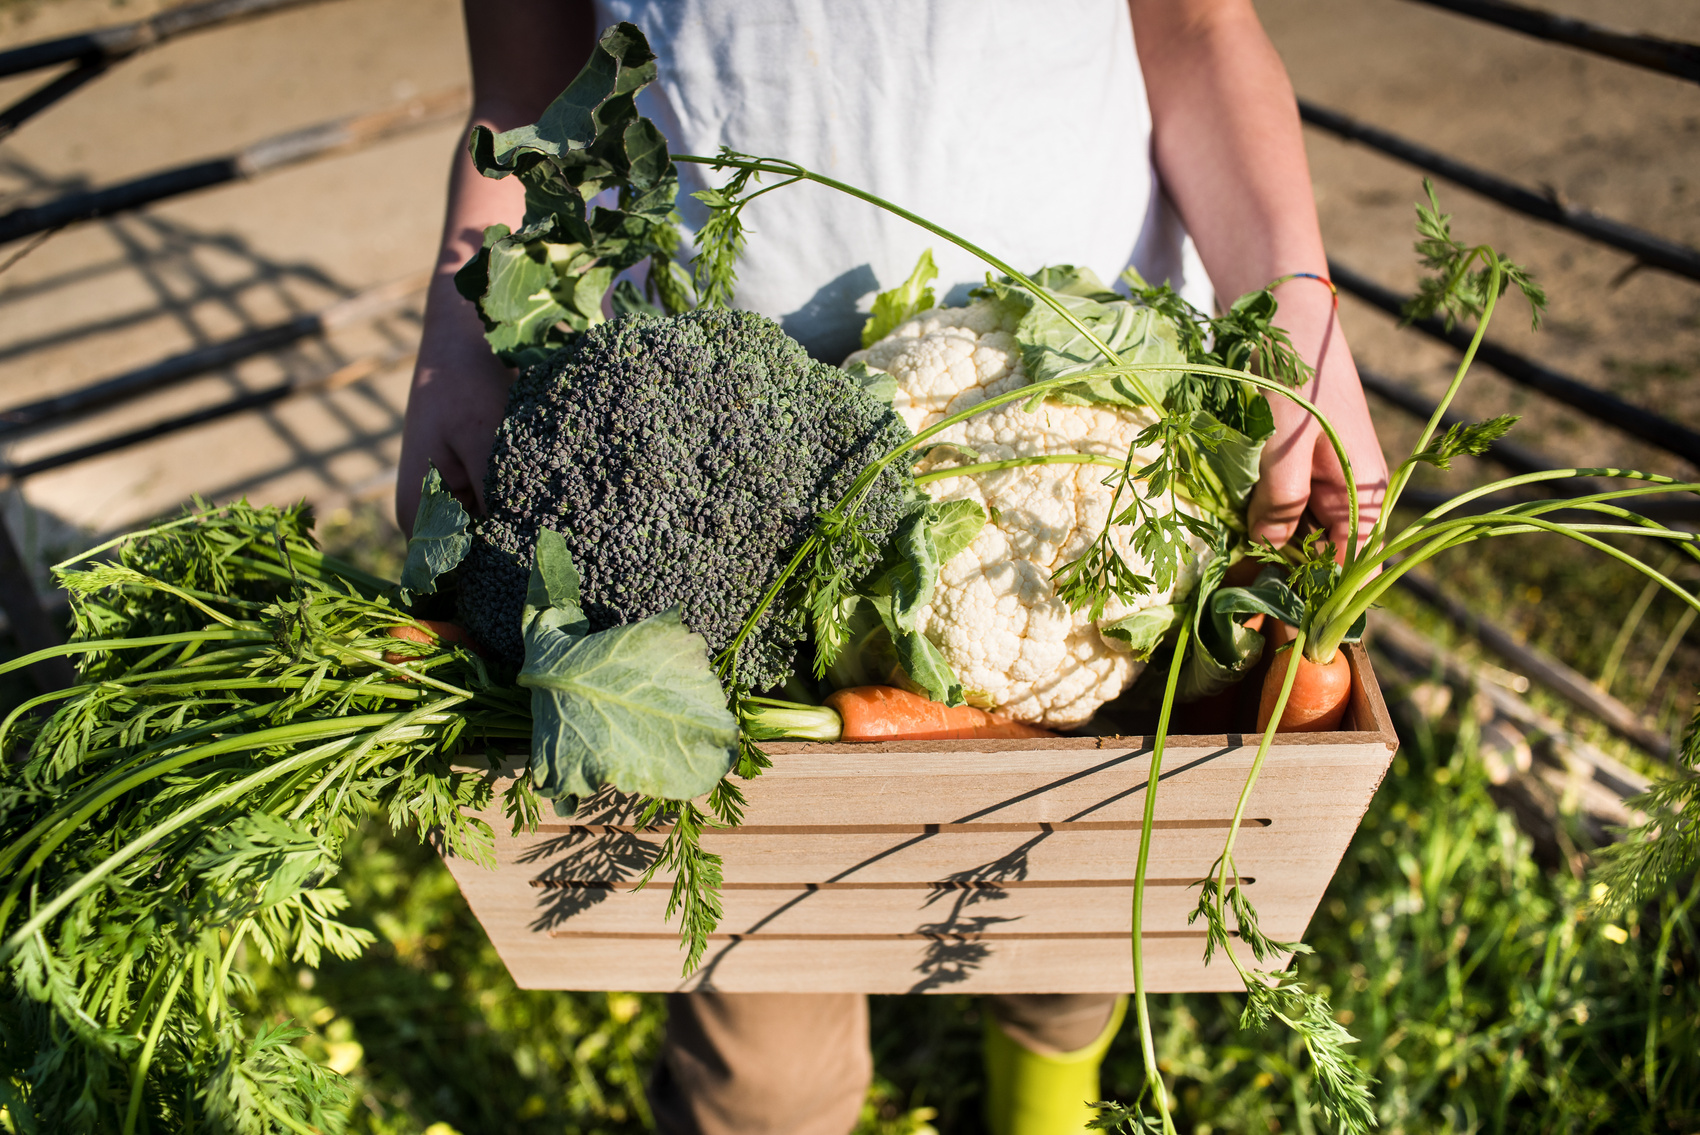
[847,301,1207,729]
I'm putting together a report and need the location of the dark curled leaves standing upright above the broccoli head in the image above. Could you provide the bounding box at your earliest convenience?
[454,24,690,367]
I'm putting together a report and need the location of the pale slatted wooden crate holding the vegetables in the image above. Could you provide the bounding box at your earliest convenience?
[449,647,1397,992]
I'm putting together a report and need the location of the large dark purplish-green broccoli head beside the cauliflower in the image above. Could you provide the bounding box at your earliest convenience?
[459,308,916,690]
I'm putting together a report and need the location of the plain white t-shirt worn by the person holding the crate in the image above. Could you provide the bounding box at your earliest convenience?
[595,0,1212,362]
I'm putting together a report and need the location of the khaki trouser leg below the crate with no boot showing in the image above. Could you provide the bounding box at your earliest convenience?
[649,992,874,1135]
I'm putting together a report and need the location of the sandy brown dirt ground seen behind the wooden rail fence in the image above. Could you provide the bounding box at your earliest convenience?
[0,0,1700,552]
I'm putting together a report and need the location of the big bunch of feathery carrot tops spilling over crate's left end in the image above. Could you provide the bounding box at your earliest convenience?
[0,503,536,1133]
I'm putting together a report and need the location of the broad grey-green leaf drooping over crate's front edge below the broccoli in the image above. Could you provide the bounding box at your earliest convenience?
[519,608,738,800]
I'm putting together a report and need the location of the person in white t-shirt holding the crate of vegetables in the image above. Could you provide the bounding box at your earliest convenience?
[396,0,1387,1135]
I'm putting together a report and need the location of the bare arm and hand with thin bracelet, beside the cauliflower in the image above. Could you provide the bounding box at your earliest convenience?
[1129,0,1387,547]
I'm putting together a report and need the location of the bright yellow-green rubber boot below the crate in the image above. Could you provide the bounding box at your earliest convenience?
[983,997,1127,1135]
